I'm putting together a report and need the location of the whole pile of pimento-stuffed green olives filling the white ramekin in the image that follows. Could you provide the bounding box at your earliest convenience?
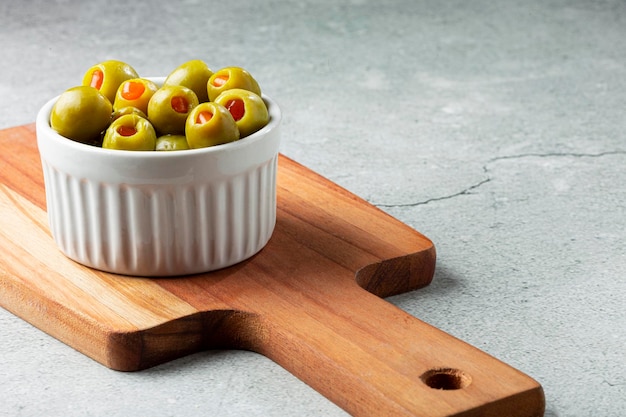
[50,59,269,151]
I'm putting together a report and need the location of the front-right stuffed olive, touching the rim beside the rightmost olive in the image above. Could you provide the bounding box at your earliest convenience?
[185,102,239,149]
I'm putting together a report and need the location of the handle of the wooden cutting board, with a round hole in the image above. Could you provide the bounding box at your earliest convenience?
[234,255,545,417]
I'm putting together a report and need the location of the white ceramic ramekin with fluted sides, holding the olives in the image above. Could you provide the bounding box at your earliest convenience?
[36,79,281,276]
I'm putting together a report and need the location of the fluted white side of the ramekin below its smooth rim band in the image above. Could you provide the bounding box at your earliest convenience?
[43,156,277,276]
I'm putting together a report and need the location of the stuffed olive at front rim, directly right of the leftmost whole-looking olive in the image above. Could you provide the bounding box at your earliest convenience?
[102,114,156,151]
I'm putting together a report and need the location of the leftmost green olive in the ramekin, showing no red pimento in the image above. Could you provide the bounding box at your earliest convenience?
[50,86,112,143]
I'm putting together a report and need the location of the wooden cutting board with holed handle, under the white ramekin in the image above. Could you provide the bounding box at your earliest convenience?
[0,125,544,417]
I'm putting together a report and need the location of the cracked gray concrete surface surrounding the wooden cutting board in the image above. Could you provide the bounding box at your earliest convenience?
[0,0,626,417]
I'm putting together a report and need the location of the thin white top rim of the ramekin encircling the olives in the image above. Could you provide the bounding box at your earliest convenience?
[36,77,282,160]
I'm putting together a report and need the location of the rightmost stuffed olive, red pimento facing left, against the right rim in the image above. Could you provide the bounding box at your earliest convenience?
[215,88,270,138]
